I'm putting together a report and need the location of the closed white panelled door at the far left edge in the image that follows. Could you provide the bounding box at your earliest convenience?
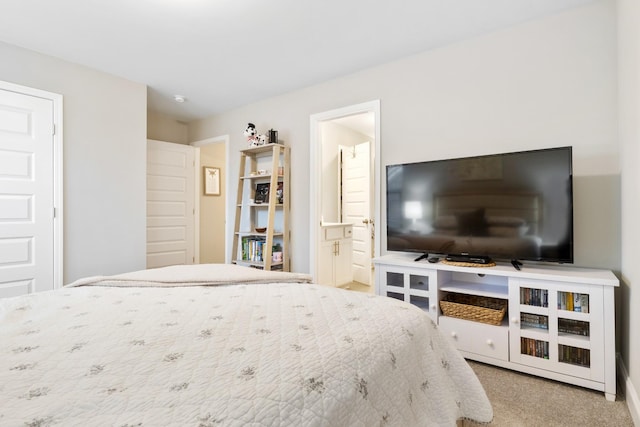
[0,89,55,297]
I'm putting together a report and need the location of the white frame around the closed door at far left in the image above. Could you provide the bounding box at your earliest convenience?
[0,80,64,289]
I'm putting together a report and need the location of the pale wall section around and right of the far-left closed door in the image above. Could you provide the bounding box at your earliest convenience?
[0,43,147,283]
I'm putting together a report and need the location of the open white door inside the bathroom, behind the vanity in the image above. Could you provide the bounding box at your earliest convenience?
[340,142,373,285]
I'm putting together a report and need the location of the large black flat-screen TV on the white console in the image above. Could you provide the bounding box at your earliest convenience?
[387,147,573,263]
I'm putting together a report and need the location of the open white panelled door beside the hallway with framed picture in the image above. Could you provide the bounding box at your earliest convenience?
[147,140,195,268]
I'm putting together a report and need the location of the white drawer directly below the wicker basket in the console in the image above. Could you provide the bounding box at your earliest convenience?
[438,316,509,361]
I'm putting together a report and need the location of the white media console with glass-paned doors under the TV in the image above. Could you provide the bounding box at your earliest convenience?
[374,254,619,400]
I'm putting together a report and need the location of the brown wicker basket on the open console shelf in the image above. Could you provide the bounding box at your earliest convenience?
[440,294,507,325]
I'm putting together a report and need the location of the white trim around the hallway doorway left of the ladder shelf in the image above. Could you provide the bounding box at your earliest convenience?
[190,135,233,264]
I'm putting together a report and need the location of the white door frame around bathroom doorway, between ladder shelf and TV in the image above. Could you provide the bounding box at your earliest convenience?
[309,99,380,286]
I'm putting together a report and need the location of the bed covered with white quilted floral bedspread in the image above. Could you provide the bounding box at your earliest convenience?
[0,264,493,426]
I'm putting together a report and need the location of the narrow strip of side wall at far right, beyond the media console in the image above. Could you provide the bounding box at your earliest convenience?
[617,0,640,425]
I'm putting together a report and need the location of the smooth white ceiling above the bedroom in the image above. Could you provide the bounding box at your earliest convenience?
[0,0,594,121]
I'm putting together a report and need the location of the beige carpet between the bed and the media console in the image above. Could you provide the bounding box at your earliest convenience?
[462,361,633,427]
